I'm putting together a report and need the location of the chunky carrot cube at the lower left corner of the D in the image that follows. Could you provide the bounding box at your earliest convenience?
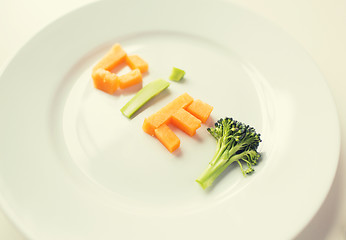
[93,68,118,94]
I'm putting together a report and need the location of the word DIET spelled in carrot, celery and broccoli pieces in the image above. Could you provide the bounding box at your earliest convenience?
[91,44,261,189]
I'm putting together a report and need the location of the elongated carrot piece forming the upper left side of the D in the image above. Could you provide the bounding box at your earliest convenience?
[93,43,126,72]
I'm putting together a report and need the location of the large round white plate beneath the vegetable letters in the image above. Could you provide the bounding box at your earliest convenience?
[0,0,339,240]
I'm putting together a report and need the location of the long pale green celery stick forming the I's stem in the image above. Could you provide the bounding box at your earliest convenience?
[120,79,169,118]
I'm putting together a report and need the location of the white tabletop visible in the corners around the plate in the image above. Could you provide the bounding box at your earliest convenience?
[0,0,346,240]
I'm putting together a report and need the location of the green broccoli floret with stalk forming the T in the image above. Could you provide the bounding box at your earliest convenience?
[196,118,261,189]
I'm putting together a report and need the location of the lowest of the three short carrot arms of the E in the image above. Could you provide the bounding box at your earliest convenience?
[155,124,180,152]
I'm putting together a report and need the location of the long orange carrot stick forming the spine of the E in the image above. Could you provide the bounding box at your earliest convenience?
[142,93,193,136]
